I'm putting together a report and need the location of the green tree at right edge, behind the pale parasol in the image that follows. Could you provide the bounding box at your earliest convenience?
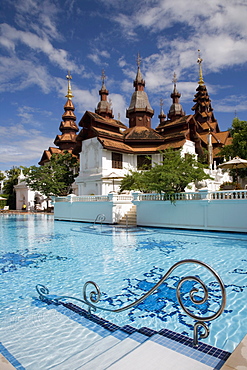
[220,117,247,178]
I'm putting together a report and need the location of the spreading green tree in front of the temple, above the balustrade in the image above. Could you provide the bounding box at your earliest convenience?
[120,149,209,194]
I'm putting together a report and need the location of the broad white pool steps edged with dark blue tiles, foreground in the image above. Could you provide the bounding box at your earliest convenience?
[0,303,230,370]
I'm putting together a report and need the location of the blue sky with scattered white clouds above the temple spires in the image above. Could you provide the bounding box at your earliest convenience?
[0,0,247,170]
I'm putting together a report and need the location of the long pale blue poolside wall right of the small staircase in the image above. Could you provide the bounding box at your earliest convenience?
[134,199,247,232]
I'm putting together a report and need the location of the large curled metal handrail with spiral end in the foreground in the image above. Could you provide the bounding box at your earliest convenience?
[36,259,226,346]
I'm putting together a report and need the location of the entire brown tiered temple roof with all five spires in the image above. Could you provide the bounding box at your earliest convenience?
[39,55,231,168]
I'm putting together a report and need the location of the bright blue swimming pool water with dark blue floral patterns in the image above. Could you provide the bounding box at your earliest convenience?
[0,214,247,369]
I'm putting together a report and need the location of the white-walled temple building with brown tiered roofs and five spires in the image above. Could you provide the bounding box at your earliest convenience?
[35,55,231,195]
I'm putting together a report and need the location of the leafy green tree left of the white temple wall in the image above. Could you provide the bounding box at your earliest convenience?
[24,152,78,198]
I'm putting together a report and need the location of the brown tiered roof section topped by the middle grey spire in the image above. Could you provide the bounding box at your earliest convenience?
[74,57,164,154]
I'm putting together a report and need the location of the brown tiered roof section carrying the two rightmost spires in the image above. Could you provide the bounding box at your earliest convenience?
[156,54,231,159]
